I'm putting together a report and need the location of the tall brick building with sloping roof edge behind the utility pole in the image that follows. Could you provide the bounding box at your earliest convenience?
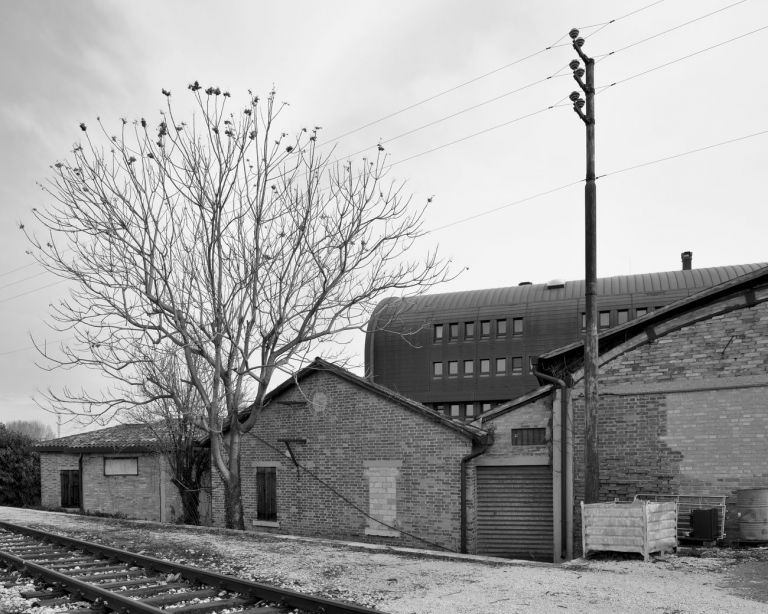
[538,267,768,560]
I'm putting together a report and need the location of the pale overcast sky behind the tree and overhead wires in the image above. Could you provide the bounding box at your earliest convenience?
[0,0,768,435]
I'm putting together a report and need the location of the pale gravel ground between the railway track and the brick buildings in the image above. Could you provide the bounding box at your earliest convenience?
[0,507,768,614]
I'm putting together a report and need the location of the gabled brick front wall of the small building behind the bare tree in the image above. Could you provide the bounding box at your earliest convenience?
[212,372,472,550]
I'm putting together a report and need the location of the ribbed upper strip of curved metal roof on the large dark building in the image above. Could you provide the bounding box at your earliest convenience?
[379,263,766,314]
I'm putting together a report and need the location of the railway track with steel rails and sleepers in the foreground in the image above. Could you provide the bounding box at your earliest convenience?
[0,522,382,614]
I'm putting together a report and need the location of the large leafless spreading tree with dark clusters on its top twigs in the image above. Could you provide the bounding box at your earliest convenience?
[25,82,447,529]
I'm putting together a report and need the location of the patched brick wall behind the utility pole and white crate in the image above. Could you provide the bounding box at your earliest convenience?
[574,302,768,543]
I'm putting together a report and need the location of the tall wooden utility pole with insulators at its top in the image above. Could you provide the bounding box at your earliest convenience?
[568,28,600,503]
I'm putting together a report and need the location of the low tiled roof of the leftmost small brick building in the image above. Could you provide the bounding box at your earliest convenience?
[35,424,157,452]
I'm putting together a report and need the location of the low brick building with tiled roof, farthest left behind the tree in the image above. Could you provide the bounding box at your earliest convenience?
[35,424,206,522]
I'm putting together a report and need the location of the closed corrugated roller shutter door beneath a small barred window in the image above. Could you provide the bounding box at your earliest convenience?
[477,465,553,561]
